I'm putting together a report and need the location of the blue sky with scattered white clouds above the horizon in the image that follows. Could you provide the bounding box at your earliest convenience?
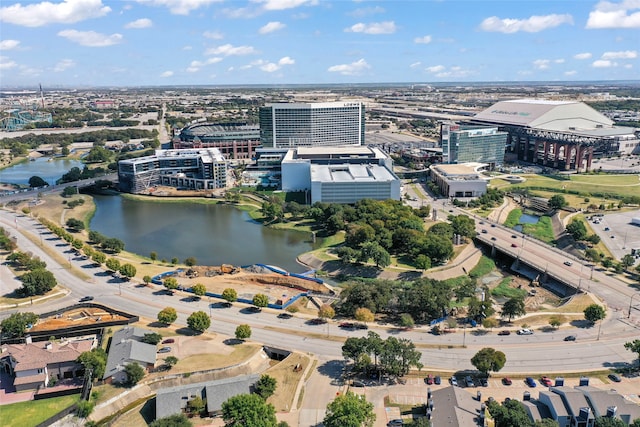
[0,0,640,87]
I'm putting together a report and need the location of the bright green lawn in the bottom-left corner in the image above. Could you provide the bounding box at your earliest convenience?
[0,394,79,427]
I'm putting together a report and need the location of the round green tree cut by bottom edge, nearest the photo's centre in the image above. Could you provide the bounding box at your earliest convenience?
[322,392,376,427]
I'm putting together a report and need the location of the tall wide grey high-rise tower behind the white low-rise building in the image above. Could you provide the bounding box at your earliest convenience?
[260,102,364,148]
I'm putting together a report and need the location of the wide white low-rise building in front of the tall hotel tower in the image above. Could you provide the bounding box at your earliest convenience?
[281,146,400,204]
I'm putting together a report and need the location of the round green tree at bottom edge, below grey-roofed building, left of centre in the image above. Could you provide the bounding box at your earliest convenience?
[222,394,278,427]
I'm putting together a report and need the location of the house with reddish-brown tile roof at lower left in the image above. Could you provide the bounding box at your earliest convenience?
[0,338,96,391]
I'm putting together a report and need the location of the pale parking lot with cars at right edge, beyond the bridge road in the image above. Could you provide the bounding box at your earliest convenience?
[587,209,640,260]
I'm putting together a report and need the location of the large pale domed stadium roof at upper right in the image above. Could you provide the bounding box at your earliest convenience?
[473,99,613,132]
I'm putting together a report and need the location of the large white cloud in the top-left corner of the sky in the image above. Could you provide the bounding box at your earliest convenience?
[0,0,111,27]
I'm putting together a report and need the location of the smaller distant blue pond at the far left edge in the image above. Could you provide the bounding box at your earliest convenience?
[0,157,84,185]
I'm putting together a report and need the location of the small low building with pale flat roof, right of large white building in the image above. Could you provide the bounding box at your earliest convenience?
[430,163,488,198]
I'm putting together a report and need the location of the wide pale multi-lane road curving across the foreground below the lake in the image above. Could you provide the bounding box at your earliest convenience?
[0,210,640,374]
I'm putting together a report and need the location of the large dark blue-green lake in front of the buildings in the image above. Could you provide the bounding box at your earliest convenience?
[91,196,321,273]
